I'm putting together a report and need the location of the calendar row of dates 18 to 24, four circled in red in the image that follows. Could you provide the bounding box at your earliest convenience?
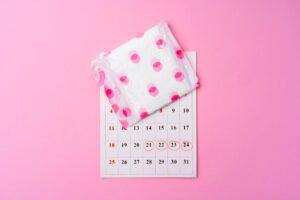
[107,140,193,151]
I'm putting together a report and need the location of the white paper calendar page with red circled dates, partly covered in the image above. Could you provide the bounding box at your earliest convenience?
[100,52,197,178]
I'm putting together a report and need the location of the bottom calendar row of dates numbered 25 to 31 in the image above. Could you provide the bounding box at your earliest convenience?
[106,157,193,175]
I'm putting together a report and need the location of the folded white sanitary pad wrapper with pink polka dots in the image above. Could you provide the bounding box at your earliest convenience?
[92,22,198,128]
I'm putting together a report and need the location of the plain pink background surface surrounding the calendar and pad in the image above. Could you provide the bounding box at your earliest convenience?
[0,0,300,200]
